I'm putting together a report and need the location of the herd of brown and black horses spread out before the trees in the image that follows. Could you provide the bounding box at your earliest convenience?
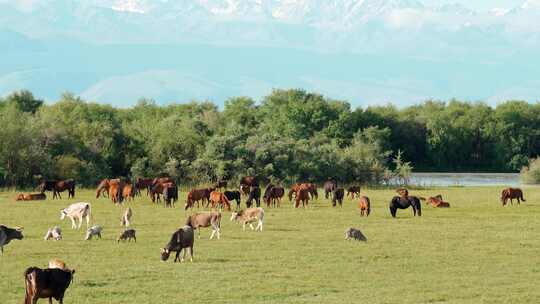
[25,176,525,217]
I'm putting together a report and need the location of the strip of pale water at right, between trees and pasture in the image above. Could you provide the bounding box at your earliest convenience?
[410,172,520,186]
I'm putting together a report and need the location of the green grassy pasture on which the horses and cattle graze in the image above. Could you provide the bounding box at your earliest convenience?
[0,187,540,304]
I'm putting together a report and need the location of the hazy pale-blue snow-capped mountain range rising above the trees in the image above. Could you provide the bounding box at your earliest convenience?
[0,0,540,106]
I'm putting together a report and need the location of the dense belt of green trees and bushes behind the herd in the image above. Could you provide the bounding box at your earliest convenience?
[0,89,540,187]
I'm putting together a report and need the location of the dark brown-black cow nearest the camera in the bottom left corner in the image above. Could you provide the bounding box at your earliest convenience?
[24,267,75,304]
